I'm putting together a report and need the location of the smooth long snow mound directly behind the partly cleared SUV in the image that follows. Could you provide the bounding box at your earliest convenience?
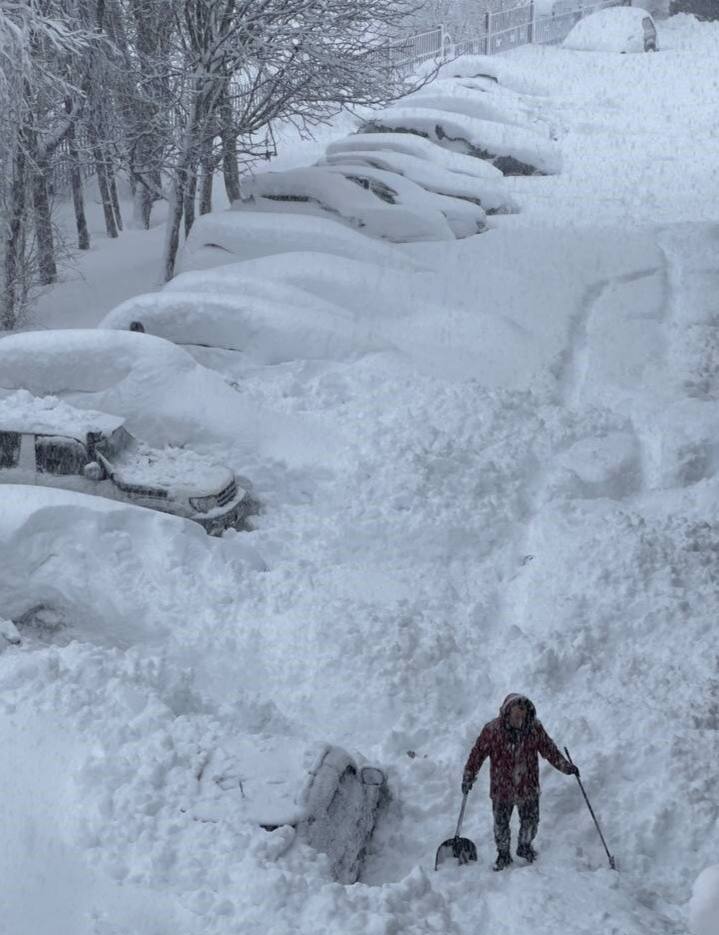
[0,329,342,468]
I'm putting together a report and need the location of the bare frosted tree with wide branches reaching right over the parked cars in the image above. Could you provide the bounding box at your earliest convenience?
[164,0,428,279]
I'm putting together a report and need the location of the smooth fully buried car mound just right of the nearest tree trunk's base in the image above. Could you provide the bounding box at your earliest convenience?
[177,211,420,272]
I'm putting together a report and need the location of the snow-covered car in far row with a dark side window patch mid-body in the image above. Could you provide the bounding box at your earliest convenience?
[324,161,487,239]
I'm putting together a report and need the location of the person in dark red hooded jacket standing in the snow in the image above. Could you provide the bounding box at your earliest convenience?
[462,694,579,870]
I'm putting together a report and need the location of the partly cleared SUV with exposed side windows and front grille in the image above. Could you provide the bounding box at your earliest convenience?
[0,390,252,534]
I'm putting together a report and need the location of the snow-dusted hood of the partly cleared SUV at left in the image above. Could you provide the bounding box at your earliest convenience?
[113,445,234,497]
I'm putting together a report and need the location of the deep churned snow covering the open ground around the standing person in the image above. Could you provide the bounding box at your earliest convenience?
[5,17,719,935]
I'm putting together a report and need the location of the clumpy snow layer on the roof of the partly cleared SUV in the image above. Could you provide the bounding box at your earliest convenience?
[0,390,125,441]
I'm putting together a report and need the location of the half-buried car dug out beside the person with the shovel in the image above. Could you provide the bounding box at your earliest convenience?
[190,735,388,883]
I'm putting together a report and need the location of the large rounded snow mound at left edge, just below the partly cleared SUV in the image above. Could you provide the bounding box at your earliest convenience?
[0,484,264,647]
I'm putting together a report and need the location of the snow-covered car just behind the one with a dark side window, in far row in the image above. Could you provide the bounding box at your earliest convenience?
[323,139,518,215]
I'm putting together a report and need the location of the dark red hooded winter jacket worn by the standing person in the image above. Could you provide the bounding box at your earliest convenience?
[464,695,572,802]
